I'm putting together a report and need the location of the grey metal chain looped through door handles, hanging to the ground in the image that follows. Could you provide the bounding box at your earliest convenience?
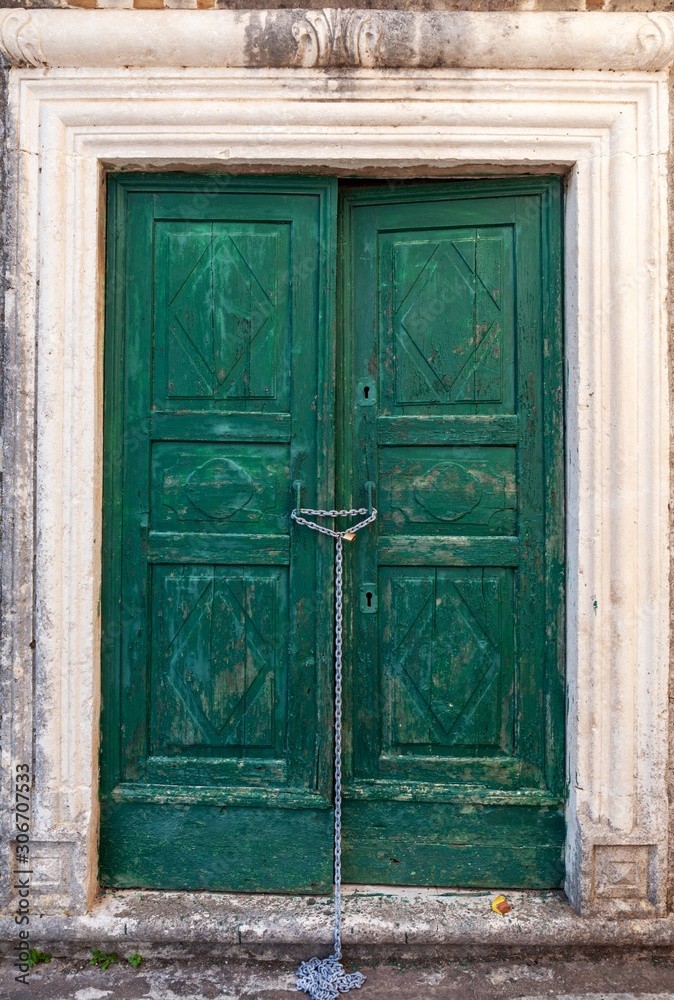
[290,504,377,1000]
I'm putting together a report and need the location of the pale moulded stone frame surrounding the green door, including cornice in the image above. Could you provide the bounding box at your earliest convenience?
[0,10,674,917]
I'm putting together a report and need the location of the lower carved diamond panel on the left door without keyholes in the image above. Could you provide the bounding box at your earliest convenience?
[152,566,286,755]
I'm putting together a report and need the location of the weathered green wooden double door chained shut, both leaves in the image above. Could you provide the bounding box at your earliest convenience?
[100,175,564,892]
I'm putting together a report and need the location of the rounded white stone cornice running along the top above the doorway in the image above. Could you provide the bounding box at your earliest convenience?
[0,8,674,71]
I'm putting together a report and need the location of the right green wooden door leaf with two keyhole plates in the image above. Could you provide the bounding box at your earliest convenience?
[338,178,564,887]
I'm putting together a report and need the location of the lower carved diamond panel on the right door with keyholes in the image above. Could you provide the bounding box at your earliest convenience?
[382,568,512,752]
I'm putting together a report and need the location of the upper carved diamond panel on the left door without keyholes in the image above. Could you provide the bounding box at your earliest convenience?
[154,222,289,409]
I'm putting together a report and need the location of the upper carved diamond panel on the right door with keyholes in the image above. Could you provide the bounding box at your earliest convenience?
[380,229,513,412]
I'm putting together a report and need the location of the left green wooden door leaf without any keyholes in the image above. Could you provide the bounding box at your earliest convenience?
[100,175,336,891]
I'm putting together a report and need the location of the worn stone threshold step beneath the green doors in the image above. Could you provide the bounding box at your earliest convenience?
[0,886,674,961]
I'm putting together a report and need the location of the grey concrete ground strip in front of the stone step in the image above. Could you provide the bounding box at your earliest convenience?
[0,951,674,1000]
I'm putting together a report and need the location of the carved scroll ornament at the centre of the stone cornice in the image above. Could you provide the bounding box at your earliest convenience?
[292,8,382,69]
